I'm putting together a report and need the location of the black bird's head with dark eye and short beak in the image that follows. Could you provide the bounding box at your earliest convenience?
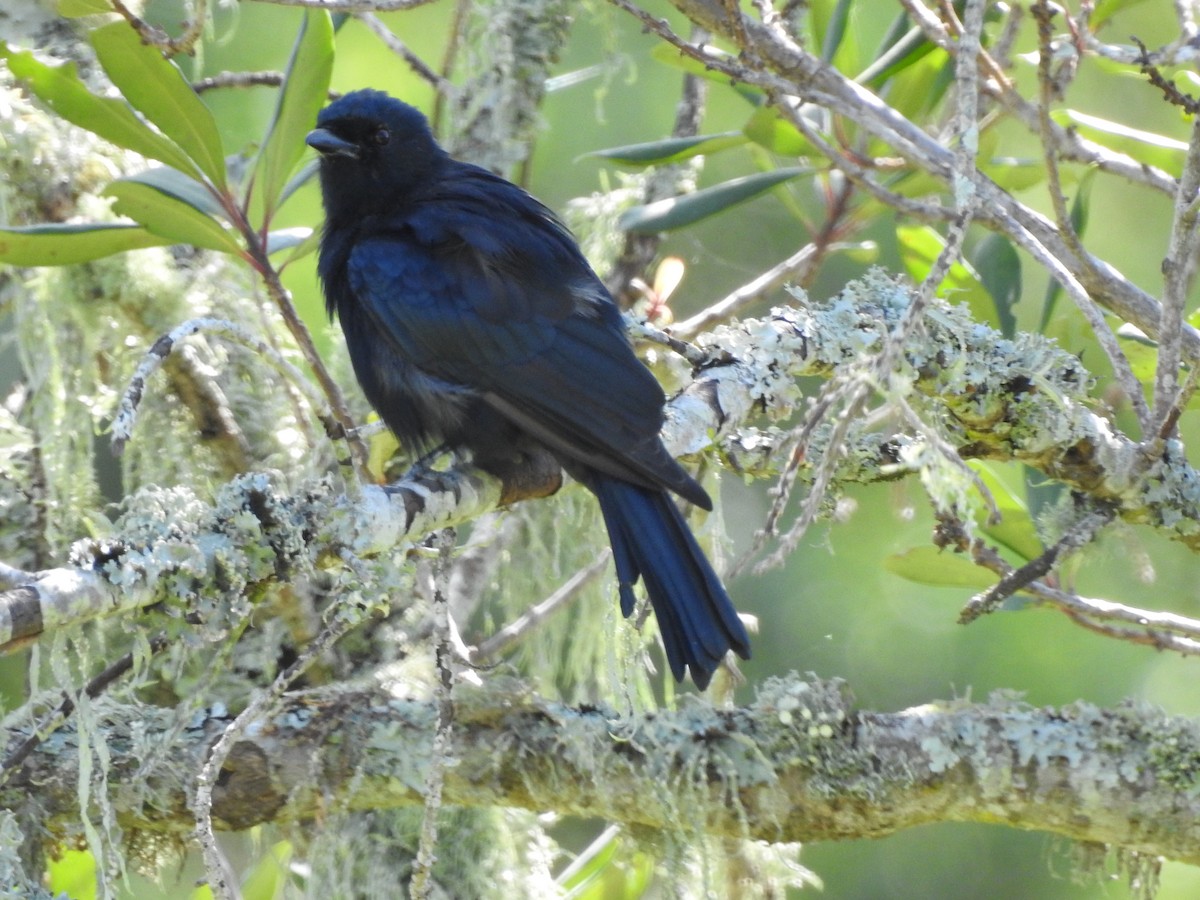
[306,90,448,222]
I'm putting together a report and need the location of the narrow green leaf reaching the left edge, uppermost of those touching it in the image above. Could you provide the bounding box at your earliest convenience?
[0,41,200,176]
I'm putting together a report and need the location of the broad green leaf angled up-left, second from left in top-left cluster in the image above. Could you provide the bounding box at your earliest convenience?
[91,20,226,188]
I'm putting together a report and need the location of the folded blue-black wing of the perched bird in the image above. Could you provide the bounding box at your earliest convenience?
[349,181,707,500]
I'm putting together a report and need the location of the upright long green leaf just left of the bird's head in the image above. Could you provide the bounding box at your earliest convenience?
[251,10,334,224]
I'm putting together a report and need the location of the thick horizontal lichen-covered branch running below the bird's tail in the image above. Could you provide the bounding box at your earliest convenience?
[0,677,1200,863]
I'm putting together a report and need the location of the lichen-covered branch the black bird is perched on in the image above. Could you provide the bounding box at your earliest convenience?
[0,272,1200,644]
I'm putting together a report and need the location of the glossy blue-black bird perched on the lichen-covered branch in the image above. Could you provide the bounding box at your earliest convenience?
[307,90,750,689]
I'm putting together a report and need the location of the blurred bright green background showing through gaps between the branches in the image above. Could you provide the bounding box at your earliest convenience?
[16,0,1200,900]
